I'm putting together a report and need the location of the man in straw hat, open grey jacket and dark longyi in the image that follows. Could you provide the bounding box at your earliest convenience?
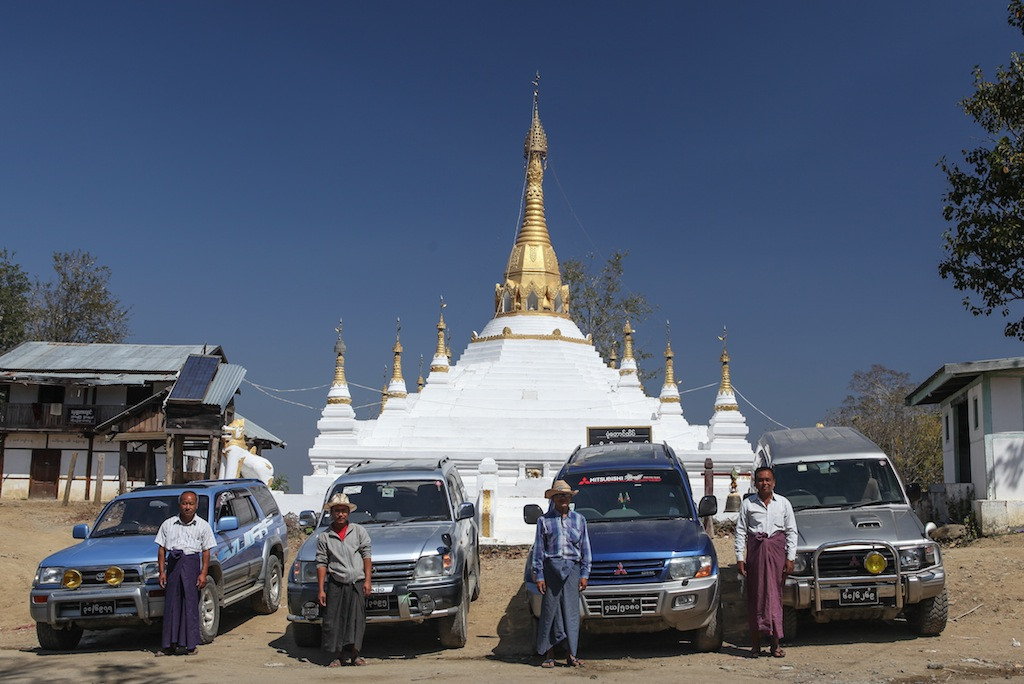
[316,494,373,668]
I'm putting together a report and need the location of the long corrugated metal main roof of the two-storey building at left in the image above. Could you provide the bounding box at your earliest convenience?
[0,342,226,375]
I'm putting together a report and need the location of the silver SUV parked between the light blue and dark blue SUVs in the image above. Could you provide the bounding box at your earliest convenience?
[288,458,480,648]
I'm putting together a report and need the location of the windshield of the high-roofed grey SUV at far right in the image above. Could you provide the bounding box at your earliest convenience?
[773,459,905,510]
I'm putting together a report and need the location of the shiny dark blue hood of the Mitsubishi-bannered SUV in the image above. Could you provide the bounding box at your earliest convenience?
[587,518,710,560]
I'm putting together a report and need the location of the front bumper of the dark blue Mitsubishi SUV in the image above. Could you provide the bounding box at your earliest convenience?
[526,575,720,632]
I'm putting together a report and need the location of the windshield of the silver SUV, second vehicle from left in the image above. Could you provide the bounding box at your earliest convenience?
[324,479,452,524]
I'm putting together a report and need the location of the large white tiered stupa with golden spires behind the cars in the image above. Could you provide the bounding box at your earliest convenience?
[303,91,753,543]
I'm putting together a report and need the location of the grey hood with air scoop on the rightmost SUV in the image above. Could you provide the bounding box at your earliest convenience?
[797,505,925,550]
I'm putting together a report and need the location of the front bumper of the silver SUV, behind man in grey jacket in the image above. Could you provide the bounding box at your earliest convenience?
[288,582,462,625]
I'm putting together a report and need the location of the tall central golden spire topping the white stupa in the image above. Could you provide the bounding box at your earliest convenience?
[495,74,569,316]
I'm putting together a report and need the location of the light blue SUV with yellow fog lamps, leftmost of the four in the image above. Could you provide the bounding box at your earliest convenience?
[29,479,288,650]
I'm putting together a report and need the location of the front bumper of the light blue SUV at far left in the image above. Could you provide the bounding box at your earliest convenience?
[29,586,164,629]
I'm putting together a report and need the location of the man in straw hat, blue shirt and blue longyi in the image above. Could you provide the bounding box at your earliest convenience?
[531,480,591,668]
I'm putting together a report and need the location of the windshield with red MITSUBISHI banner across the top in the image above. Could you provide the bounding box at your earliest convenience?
[565,470,690,522]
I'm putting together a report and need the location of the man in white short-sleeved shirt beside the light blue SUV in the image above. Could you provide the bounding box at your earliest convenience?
[155,491,217,655]
